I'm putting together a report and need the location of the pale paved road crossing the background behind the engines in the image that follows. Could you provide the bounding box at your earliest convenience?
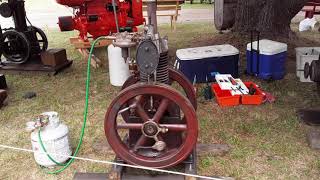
[0,0,320,28]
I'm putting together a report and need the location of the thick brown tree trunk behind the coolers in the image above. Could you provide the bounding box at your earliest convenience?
[233,0,309,36]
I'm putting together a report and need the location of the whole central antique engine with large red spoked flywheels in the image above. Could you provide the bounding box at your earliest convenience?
[104,0,198,173]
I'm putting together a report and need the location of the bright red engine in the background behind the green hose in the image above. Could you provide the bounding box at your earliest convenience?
[56,0,144,40]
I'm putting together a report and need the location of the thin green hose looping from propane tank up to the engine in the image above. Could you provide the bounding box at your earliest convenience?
[38,37,106,174]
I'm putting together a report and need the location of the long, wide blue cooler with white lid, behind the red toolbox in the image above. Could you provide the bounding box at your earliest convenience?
[175,44,239,83]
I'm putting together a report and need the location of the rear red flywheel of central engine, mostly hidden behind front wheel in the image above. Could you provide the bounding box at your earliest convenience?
[122,68,197,110]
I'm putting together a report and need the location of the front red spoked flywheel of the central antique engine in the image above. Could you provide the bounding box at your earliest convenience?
[104,83,198,168]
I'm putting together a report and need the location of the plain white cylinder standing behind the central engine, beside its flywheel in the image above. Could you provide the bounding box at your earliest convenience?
[108,44,130,86]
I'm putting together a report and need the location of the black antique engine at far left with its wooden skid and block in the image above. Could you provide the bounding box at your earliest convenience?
[0,0,72,75]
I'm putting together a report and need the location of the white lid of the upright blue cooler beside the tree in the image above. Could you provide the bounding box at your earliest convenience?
[247,39,288,55]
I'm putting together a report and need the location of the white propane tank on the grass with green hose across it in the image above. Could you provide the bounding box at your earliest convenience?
[27,112,72,167]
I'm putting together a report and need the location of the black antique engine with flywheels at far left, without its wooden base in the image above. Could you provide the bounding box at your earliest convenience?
[0,0,48,64]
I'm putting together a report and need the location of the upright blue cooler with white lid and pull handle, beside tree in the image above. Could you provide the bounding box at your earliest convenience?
[247,39,288,80]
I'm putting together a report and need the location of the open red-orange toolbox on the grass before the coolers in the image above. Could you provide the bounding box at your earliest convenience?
[211,82,264,107]
